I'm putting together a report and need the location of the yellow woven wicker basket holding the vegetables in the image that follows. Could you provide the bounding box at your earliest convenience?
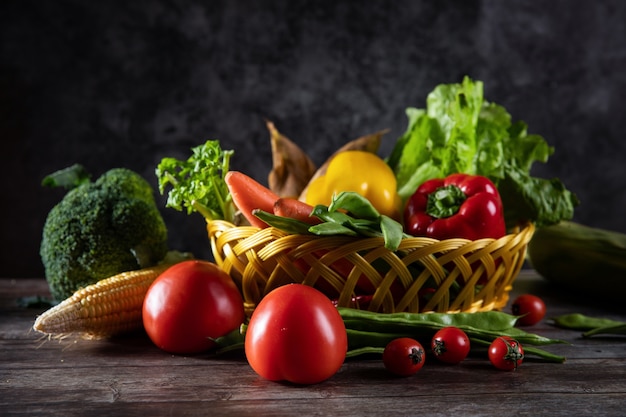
[207,221,535,315]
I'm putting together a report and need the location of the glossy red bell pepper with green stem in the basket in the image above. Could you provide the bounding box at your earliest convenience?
[404,174,506,240]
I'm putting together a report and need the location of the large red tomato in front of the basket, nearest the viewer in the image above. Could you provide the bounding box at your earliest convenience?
[245,284,348,384]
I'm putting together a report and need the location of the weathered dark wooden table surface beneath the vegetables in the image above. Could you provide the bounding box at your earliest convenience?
[0,270,626,417]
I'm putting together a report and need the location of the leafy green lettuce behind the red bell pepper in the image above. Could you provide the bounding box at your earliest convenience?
[388,77,578,227]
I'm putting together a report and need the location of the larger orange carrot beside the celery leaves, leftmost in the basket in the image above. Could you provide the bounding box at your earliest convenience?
[224,171,279,228]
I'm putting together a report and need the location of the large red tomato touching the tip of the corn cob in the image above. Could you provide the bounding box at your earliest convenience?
[143,260,245,353]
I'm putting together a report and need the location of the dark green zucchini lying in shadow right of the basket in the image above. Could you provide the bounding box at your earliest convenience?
[527,221,626,302]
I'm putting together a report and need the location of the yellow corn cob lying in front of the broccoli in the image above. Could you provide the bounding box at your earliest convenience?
[33,252,190,339]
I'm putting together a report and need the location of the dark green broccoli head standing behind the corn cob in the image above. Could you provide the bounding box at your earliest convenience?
[40,167,168,300]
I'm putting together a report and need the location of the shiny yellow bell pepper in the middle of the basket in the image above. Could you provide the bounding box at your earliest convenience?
[305,151,401,219]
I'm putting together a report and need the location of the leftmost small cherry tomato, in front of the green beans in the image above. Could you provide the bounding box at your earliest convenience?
[383,337,426,376]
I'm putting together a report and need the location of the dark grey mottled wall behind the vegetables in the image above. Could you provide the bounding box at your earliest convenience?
[0,0,626,277]
